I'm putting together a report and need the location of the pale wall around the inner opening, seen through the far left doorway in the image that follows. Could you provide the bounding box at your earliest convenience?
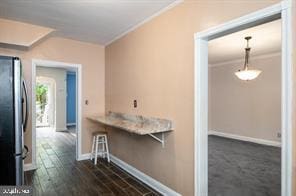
[36,65,67,131]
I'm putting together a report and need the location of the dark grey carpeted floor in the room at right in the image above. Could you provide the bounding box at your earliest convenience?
[209,136,281,196]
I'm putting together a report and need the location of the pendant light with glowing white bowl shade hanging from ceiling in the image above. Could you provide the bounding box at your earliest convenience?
[235,36,262,81]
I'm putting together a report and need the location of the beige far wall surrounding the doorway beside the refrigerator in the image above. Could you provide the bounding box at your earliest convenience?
[0,38,105,163]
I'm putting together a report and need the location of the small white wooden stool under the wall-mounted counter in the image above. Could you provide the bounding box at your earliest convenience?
[90,131,110,165]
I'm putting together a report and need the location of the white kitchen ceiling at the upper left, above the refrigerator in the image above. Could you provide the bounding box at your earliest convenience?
[0,0,178,45]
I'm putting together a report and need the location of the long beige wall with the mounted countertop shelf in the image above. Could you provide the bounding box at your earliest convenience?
[106,0,277,196]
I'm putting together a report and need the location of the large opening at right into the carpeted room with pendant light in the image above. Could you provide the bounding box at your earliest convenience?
[208,20,281,196]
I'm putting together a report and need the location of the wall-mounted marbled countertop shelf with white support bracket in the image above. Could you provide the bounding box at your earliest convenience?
[88,112,173,147]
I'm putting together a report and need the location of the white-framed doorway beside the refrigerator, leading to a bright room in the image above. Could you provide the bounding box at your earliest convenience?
[32,59,82,168]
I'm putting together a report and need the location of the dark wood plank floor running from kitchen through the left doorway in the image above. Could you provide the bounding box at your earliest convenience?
[25,128,160,196]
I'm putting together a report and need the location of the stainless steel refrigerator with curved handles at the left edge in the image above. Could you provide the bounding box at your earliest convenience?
[0,56,28,185]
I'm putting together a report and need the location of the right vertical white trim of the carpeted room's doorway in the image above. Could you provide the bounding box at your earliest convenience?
[281,1,294,196]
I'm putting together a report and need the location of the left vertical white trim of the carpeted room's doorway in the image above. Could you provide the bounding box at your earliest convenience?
[194,36,208,196]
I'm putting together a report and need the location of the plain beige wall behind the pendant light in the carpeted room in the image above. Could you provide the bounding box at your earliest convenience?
[209,53,281,142]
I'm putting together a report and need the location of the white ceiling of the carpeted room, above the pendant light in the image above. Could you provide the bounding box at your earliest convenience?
[209,20,281,65]
